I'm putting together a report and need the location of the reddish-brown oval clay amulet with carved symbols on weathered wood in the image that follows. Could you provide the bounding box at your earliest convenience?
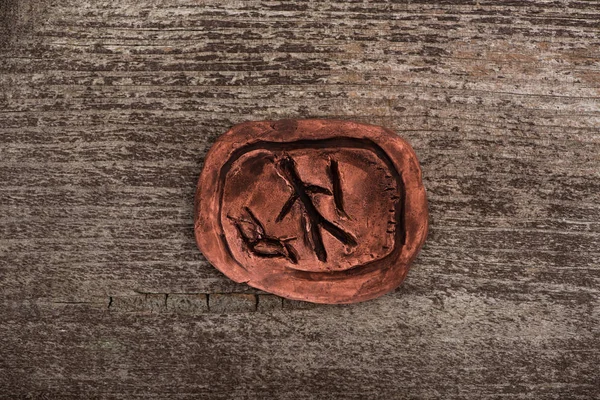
[195,120,427,303]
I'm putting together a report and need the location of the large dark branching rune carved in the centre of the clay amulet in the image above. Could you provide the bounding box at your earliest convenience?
[275,155,357,262]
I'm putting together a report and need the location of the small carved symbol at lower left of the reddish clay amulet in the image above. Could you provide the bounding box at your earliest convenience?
[227,207,298,264]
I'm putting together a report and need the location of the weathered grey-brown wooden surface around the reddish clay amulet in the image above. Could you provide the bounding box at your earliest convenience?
[0,0,600,400]
